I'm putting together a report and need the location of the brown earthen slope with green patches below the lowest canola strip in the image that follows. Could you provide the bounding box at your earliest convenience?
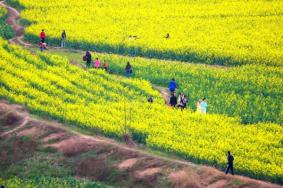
[0,101,279,188]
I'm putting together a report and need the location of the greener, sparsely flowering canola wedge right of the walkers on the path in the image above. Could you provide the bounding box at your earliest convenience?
[51,51,283,124]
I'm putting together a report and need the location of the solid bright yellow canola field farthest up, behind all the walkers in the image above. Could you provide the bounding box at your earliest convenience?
[7,0,283,66]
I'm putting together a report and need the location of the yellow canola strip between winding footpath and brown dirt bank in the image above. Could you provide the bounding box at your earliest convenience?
[0,40,283,183]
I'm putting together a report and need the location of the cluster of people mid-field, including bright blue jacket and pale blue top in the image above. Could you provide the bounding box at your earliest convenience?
[168,78,207,114]
